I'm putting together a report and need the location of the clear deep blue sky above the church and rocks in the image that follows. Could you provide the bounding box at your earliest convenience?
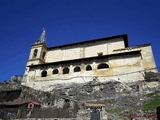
[0,0,160,81]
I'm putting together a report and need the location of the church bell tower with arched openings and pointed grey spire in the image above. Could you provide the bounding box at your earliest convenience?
[27,29,47,66]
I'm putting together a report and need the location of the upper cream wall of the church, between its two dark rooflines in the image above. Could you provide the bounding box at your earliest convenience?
[45,38,125,63]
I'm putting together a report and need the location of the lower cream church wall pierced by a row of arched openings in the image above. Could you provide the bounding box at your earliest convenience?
[23,54,145,89]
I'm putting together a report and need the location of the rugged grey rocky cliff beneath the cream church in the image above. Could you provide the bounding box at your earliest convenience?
[0,73,160,120]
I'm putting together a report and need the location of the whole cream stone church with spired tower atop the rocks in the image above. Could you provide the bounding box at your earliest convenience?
[22,29,157,89]
